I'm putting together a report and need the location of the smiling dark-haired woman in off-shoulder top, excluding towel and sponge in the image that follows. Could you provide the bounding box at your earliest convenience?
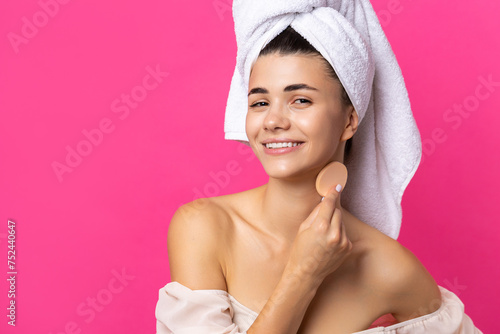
[157,1,479,334]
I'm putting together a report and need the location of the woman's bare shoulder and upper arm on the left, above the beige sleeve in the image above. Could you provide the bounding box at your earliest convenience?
[167,192,258,291]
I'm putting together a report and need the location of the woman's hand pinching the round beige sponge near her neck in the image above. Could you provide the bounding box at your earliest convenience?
[285,187,352,286]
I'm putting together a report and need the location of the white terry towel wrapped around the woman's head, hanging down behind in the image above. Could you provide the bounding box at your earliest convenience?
[224,0,422,239]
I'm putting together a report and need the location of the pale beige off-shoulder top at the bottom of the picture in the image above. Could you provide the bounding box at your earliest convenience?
[155,282,482,334]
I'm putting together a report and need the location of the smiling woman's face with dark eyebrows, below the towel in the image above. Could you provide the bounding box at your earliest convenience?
[246,53,357,178]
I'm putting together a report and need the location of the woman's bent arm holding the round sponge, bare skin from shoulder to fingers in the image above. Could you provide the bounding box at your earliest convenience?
[168,189,352,334]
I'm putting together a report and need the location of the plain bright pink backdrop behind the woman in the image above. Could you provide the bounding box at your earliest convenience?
[0,0,500,334]
